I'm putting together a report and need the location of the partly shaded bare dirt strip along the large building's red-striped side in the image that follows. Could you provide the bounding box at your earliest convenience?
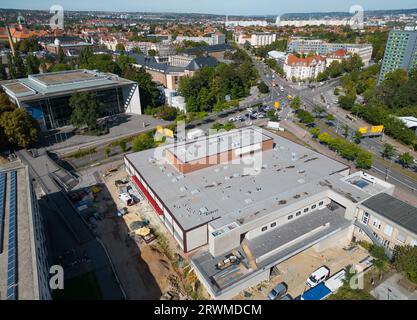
[97,168,193,299]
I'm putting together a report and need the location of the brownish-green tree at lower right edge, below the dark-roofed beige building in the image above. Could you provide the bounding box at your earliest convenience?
[394,245,417,284]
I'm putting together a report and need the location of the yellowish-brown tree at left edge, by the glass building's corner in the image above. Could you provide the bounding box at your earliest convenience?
[0,108,39,148]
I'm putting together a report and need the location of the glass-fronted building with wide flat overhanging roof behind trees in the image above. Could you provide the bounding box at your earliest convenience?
[0,69,142,131]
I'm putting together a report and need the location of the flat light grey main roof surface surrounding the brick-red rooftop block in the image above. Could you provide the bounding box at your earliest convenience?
[126,127,370,230]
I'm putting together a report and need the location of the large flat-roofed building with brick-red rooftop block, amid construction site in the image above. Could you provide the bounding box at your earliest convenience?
[125,127,417,299]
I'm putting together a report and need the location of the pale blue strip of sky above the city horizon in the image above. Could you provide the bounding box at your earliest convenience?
[0,0,417,15]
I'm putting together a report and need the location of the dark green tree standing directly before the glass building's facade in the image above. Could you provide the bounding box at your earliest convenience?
[69,92,100,130]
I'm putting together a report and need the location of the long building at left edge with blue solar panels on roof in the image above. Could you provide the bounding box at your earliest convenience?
[0,162,51,300]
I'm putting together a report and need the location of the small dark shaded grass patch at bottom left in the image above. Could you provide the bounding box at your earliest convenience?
[54,272,102,300]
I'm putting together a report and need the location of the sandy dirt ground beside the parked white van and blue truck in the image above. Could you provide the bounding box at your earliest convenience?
[235,246,369,300]
